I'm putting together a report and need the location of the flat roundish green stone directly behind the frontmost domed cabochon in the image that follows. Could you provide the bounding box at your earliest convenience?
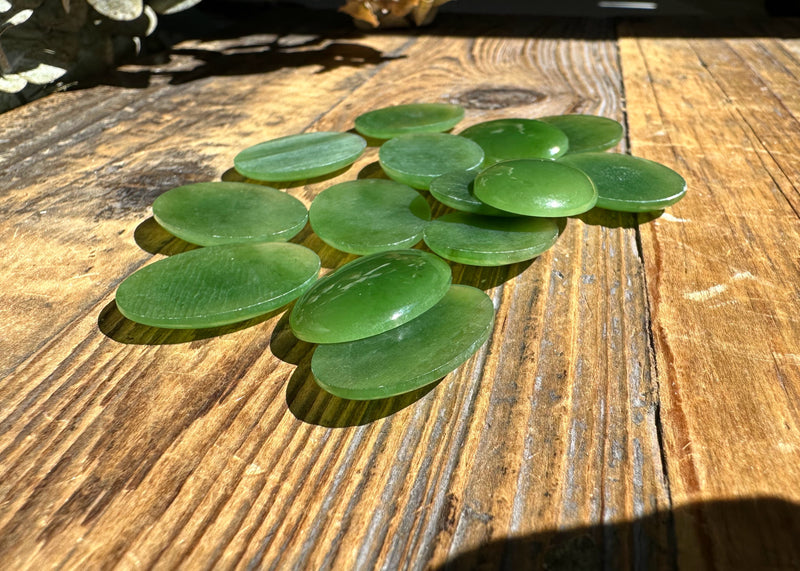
[310,178,431,255]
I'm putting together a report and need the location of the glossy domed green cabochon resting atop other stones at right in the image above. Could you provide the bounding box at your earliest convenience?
[474,159,597,217]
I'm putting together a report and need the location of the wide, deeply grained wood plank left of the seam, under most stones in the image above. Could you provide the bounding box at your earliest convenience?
[0,15,672,569]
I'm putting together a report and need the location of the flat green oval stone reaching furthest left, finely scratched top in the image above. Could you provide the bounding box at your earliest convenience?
[117,242,320,329]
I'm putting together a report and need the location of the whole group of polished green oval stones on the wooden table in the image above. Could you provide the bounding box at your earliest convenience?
[116,103,686,400]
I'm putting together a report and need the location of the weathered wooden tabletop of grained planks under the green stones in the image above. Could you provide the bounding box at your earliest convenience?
[0,12,800,570]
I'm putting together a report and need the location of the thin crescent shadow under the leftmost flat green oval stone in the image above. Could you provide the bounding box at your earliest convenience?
[97,301,285,345]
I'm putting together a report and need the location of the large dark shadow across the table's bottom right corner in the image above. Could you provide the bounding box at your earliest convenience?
[434,497,800,571]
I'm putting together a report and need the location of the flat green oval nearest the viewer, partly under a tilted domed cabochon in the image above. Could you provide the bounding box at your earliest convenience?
[311,285,494,400]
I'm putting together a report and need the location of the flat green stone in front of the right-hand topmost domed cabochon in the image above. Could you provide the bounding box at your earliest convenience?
[425,212,558,266]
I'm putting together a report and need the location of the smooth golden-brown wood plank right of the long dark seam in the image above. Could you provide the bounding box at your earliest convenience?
[620,19,800,569]
